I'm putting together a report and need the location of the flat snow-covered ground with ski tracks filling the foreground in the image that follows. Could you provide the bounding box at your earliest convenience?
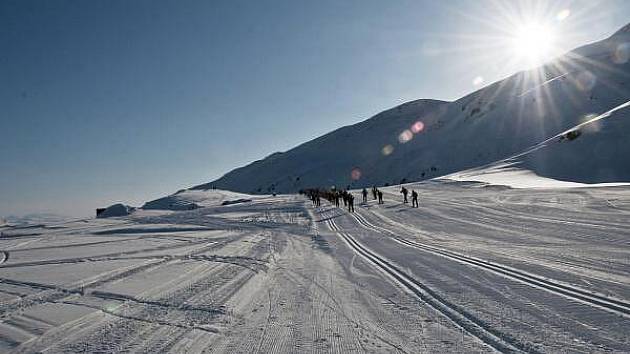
[0,187,630,353]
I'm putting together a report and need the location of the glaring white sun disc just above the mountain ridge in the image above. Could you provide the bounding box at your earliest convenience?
[512,22,556,66]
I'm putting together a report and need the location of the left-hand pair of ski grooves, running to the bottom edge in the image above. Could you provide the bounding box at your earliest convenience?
[325,212,536,353]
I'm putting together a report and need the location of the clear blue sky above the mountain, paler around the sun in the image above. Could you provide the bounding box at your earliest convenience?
[0,0,630,216]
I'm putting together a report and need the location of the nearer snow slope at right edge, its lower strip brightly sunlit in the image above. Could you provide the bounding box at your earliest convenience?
[444,101,630,187]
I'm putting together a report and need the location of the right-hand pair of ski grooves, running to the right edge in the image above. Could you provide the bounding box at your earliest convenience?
[350,209,630,318]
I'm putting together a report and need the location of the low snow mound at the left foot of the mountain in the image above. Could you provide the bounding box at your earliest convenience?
[142,189,252,210]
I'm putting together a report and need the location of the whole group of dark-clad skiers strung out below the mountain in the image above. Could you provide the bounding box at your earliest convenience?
[300,186,419,213]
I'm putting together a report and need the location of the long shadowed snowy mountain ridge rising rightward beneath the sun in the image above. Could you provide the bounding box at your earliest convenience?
[193,26,630,194]
